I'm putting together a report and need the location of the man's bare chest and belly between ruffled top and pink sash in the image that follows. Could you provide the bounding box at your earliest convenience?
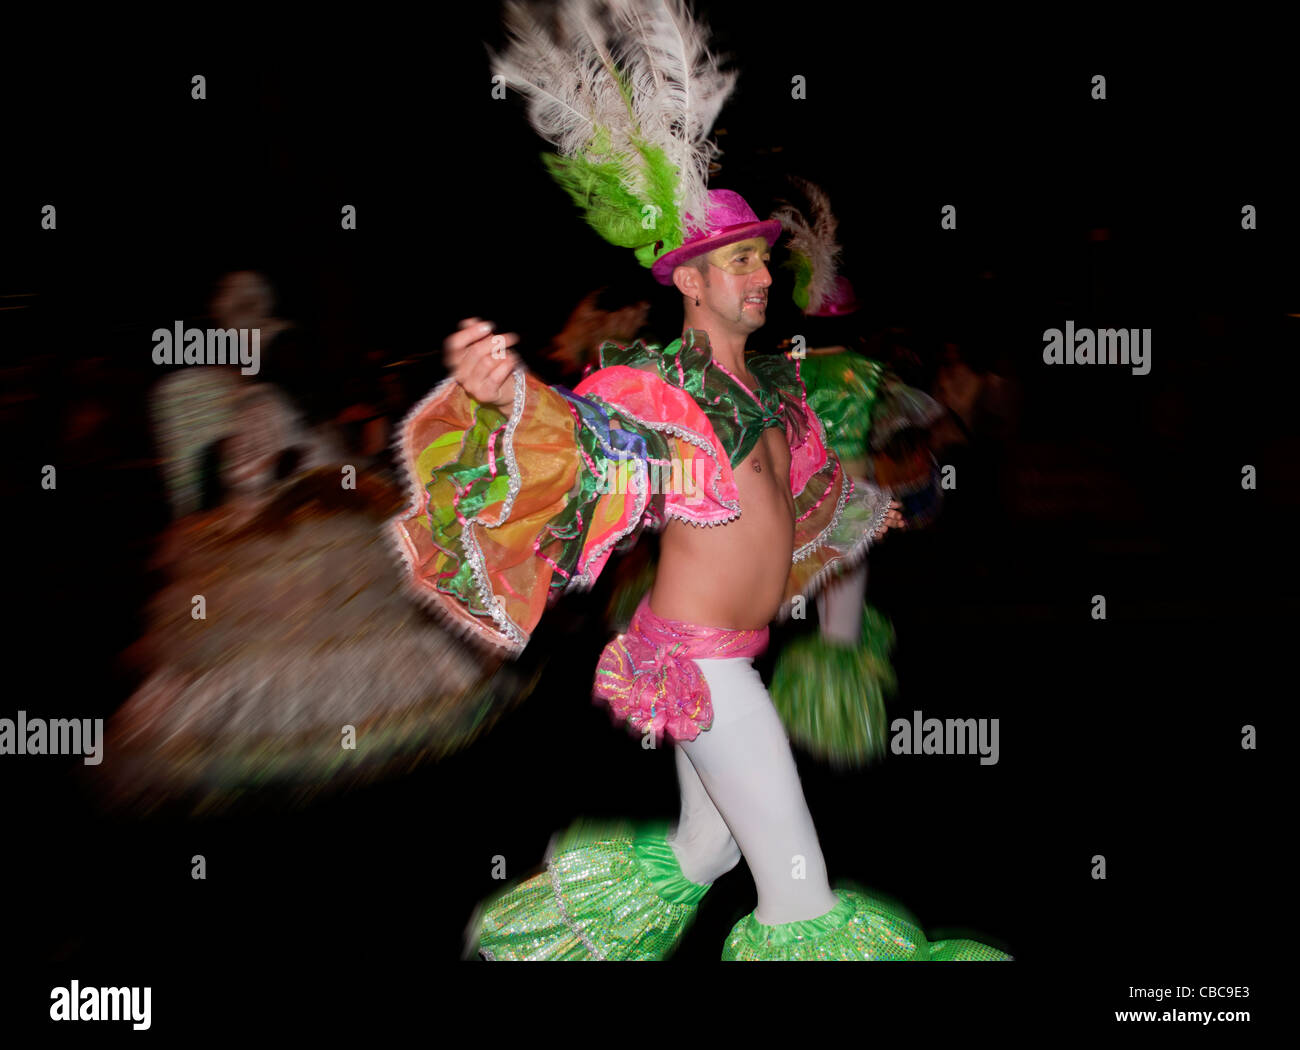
[650,428,794,630]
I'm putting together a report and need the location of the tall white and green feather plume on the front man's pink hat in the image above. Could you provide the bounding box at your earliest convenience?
[493,0,736,266]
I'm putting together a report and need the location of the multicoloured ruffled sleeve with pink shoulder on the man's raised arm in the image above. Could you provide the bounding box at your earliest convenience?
[390,369,735,655]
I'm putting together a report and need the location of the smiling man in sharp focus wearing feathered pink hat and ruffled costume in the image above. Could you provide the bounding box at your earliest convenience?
[393,0,1006,960]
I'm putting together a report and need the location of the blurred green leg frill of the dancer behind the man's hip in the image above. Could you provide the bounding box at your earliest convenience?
[768,604,896,768]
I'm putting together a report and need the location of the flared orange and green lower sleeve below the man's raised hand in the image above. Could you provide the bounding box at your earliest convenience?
[391,372,668,655]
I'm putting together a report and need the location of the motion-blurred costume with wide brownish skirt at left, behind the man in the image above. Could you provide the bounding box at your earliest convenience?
[96,369,536,812]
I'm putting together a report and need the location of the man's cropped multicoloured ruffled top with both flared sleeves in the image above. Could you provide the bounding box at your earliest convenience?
[393,330,889,654]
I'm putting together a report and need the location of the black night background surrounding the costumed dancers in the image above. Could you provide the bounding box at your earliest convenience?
[0,3,1284,1040]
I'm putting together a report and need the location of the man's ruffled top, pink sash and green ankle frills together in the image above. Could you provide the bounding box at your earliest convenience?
[390,330,1005,960]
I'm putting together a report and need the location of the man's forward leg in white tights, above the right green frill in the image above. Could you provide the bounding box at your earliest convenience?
[679,659,839,925]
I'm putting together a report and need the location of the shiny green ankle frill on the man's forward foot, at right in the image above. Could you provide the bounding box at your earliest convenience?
[723,886,1011,963]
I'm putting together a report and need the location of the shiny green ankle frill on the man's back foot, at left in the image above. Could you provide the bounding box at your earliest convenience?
[471,821,712,962]
